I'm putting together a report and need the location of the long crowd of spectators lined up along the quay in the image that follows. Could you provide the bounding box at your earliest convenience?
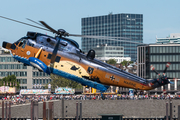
[2,94,180,105]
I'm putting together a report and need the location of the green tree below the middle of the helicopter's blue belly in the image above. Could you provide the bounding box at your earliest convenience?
[45,74,82,89]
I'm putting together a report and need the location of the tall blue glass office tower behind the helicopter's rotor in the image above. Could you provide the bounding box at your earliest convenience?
[81,13,143,61]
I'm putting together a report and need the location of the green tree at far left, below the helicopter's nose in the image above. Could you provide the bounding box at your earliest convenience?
[0,75,20,88]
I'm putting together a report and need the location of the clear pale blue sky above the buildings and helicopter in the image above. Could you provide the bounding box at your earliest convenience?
[0,0,180,46]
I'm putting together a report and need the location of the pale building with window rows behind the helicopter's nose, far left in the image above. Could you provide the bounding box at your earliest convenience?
[0,49,51,89]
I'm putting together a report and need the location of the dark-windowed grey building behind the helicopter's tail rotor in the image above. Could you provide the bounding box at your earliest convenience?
[137,44,180,94]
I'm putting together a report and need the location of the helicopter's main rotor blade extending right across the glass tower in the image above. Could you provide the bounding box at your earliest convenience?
[69,34,145,44]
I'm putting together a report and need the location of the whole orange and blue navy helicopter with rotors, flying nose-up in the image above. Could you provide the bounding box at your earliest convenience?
[0,16,174,98]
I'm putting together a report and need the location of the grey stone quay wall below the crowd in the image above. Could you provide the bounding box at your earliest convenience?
[0,100,180,118]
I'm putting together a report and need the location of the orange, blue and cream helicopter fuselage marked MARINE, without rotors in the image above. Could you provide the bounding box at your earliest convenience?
[3,32,165,90]
